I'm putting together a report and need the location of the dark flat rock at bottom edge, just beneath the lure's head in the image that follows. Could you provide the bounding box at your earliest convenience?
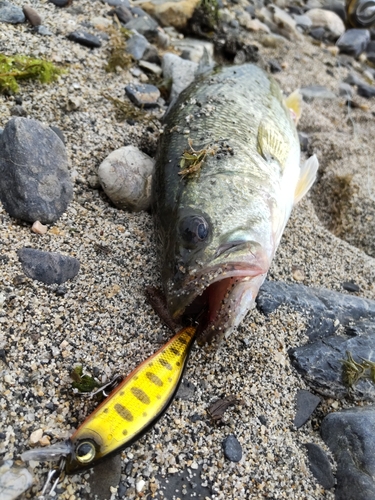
[88,454,121,500]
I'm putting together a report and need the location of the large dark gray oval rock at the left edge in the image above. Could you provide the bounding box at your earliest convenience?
[0,118,73,224]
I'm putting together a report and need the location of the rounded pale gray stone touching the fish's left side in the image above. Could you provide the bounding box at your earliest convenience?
[98,146,154,212]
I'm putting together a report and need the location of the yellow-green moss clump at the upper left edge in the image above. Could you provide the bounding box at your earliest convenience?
[0,53,64,93]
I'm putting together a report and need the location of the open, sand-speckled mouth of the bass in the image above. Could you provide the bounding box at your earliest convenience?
[168,243,269,344]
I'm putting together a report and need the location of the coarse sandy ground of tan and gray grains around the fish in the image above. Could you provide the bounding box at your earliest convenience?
[0,0,375,500]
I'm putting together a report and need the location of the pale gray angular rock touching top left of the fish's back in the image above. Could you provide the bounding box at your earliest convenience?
[162,52,198,101]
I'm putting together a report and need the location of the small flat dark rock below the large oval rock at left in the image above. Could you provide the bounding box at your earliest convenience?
[17,247,80,285]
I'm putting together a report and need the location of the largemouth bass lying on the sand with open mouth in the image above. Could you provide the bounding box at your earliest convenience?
[152,64,319,344]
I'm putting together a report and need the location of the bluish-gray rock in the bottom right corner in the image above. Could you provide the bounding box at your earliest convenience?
[321,406,375,500]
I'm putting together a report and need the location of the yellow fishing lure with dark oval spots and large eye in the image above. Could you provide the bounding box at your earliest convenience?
[21,327,196,494]
